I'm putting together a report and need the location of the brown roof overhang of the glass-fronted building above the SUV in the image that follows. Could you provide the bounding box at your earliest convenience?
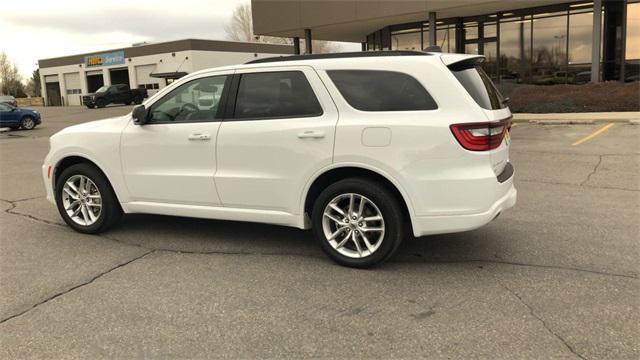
[251,0,569,42]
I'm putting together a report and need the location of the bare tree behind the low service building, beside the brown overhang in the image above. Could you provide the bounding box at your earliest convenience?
[224,4,339,53]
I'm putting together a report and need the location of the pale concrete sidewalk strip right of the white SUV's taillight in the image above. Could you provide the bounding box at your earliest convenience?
[513,111,640,124]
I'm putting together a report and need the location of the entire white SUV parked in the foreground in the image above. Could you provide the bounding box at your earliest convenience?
[42,51,516,267]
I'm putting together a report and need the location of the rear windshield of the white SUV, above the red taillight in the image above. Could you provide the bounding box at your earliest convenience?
[449,59,507,110]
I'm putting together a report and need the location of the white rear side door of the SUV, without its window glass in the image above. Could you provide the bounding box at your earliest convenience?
[215,66,338,215]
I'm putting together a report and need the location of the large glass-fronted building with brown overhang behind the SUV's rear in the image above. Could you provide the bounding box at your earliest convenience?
[251,0,640,84]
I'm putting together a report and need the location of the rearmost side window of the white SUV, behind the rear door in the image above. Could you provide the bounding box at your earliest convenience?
[327,70,438,111]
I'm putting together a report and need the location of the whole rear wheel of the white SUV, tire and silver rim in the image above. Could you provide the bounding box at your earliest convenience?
[312,178,404,268]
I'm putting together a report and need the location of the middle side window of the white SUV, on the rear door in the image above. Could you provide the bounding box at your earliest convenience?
[234,71,322,119]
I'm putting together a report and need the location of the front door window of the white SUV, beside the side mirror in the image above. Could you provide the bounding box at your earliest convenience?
[148,75,227,123]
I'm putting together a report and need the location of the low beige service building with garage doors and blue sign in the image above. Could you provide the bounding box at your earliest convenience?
[38,39,293,106]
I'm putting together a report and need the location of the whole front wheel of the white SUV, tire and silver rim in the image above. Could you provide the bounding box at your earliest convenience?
[55,164,122,234]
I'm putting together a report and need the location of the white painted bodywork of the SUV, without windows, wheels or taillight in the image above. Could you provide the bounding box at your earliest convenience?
[42,54,517,236]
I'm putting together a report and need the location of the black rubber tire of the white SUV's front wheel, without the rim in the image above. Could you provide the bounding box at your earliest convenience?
[54,164,122,234]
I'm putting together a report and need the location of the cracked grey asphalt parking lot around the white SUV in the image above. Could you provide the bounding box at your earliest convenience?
[0,107,640,359]
